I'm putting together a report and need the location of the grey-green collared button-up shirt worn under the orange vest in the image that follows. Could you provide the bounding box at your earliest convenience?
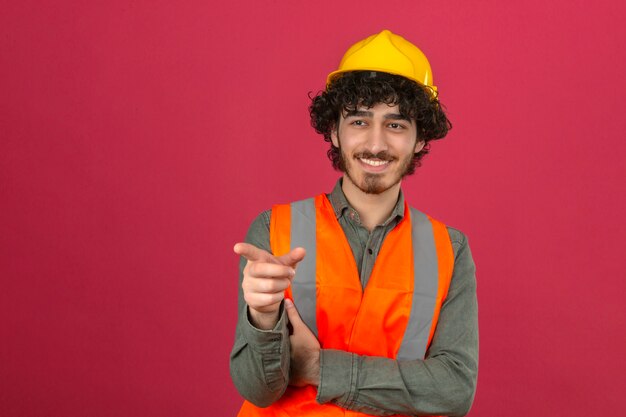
[230,180,478,415]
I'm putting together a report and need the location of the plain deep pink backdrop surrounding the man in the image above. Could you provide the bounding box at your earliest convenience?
[0,0,626,417]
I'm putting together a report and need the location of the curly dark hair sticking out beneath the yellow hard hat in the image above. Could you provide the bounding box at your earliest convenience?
[309,71,452,175]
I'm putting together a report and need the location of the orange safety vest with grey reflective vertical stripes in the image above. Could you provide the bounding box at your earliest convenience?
[239,194,454,417]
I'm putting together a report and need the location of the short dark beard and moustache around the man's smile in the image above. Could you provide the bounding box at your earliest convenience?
[339,147,414,194]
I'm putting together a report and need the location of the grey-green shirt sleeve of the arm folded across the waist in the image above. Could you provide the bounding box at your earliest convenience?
[317,228,478,416]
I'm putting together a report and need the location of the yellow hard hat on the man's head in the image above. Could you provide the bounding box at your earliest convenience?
[326,30,437,92]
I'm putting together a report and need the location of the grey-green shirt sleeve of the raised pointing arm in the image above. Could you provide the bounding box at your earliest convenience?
[230,211,290,407]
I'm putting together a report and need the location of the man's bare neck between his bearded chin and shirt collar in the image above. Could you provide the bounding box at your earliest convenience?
[341,175,400,232]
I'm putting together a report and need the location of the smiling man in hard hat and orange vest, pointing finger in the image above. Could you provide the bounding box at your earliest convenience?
[231,30,478,416]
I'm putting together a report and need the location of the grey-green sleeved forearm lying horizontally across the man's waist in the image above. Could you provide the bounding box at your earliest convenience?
[317,350,475,416]
